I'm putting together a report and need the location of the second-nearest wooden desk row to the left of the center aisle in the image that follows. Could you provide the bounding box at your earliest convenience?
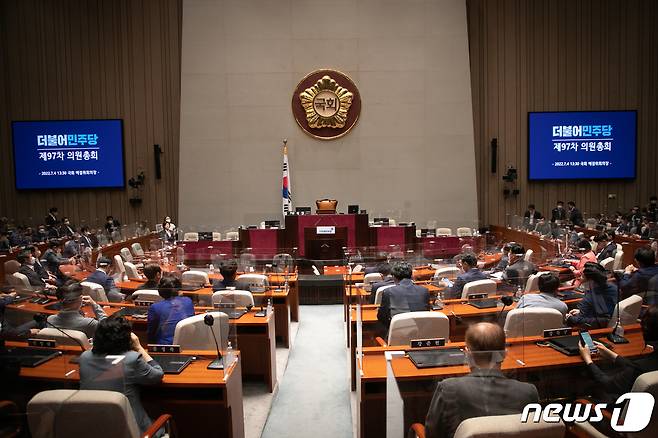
[7,301,277,392]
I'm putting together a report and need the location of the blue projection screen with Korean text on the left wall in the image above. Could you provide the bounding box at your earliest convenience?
[12,120,125,189]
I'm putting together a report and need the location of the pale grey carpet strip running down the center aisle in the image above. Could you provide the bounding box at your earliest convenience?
[262,305,352,438]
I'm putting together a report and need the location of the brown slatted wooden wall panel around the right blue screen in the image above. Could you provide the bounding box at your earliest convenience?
[467,0,658,224]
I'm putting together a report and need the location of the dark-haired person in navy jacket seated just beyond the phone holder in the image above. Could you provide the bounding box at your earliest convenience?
[565,263,617,329]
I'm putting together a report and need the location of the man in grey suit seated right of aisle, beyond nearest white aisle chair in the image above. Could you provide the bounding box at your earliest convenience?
[377,262,430,332]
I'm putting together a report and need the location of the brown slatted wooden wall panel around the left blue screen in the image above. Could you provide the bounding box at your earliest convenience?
[0,0,182,229]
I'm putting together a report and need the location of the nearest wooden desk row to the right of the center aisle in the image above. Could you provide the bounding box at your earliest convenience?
[357,325,649,438]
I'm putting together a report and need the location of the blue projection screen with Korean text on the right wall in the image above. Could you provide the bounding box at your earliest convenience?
[528,111,637,180]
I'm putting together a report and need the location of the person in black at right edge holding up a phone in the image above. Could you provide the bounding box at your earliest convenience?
[580,306,658,402]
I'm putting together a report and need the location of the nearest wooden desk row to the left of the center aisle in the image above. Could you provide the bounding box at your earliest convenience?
[3,342,244,438]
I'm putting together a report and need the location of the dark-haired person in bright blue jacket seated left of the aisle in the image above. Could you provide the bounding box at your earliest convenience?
[146,277,194,345]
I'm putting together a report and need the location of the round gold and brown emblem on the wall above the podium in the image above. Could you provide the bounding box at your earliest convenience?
[292,70,361,140]
